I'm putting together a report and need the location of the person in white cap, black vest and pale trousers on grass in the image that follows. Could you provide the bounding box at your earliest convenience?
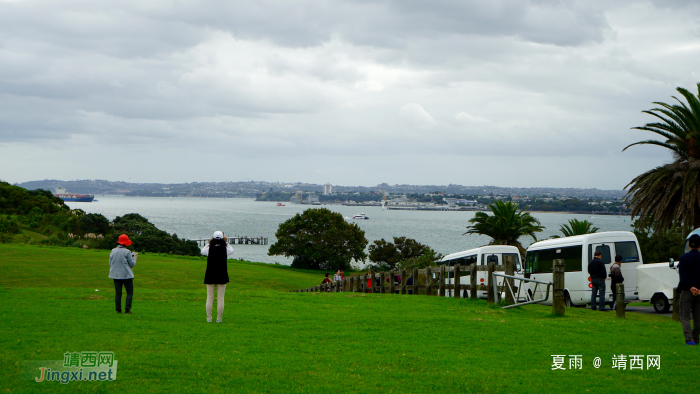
[202,231,233,323]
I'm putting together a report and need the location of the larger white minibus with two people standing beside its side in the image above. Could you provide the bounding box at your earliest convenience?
[525,231,643,307]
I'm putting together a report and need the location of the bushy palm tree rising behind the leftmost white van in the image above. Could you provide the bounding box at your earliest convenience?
[462,201,544,255]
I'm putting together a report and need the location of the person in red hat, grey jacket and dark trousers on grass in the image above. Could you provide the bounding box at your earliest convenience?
[109,234,136,315]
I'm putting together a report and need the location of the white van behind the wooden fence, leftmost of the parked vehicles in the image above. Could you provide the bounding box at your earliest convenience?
[440,245,522,298]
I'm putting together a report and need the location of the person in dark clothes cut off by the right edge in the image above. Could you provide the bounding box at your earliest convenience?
[678,234,700,346]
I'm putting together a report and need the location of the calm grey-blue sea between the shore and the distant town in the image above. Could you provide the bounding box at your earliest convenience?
[67,196,631,264]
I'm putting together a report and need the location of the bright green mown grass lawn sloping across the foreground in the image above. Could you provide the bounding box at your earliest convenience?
[0,245,700,393]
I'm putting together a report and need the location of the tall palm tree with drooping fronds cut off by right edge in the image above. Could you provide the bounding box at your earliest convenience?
[622,83,700,232]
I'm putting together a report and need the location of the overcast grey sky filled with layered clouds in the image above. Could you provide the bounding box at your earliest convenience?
[0,0,700,189]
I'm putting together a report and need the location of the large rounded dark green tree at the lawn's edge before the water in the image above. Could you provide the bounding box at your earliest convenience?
[267,208,367,270]
